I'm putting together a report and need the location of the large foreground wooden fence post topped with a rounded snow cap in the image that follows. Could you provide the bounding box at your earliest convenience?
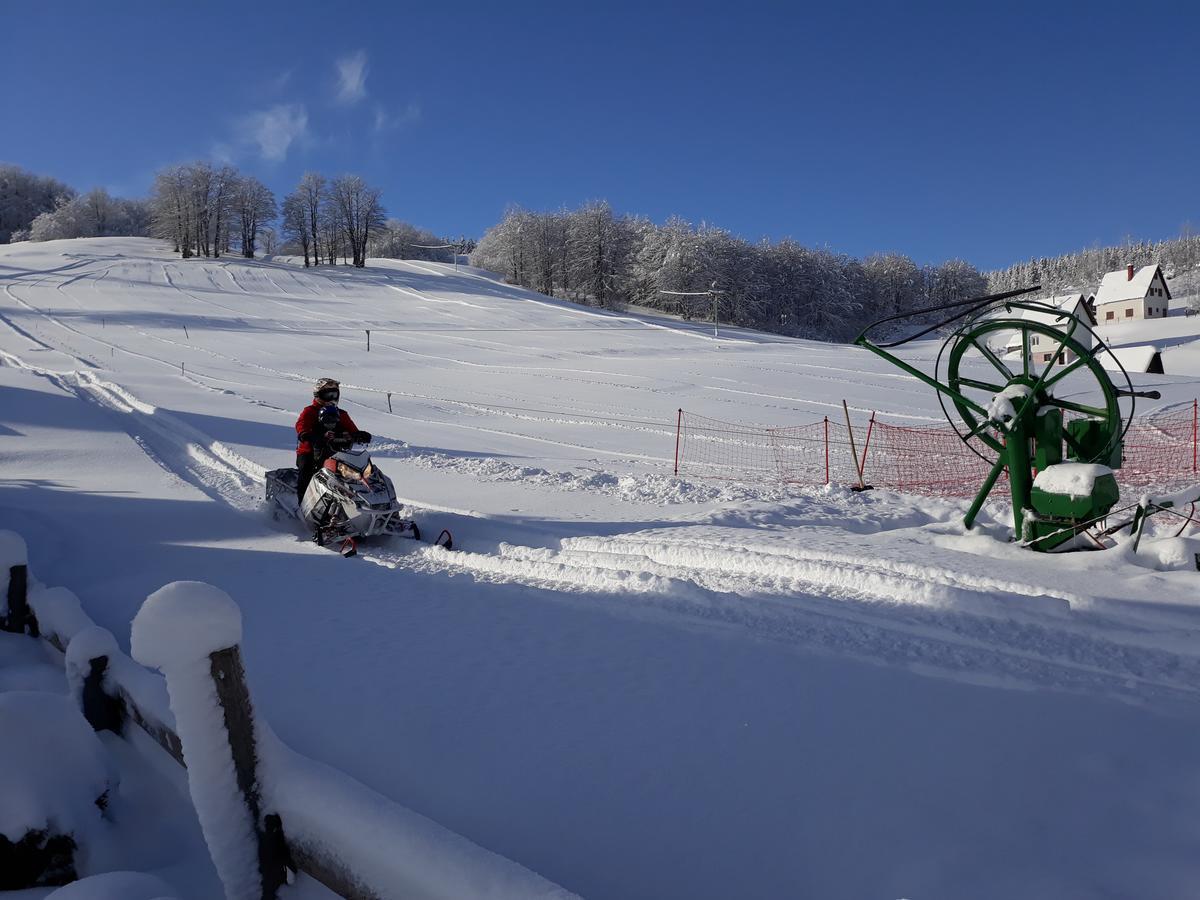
[130,581,287,900]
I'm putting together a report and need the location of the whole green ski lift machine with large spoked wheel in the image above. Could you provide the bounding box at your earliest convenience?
[854,286,1158,551]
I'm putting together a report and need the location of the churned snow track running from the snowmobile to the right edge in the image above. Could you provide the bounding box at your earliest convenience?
[373,535,1200,706]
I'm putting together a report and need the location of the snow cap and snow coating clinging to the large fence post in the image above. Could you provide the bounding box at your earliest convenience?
[131,581,262,900]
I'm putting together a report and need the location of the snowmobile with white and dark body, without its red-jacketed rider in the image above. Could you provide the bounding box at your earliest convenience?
[266,437,454,557]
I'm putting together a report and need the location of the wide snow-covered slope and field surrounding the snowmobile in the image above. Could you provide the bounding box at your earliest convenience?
[0,239,1200,900]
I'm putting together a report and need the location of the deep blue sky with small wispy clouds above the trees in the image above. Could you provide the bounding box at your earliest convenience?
[0,0,1200,268]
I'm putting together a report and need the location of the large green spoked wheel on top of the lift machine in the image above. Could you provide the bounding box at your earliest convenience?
[938,317,1133,462]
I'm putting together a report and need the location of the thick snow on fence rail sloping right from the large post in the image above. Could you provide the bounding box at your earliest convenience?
[259,726,575,900]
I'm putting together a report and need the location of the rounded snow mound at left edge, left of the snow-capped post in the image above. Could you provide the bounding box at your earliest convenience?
[0,691,108,846]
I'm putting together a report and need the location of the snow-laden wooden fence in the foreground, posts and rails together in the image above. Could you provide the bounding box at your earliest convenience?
[0,532,574,900]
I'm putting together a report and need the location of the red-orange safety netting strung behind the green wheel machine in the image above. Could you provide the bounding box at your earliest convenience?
[676,404,1200,497]
